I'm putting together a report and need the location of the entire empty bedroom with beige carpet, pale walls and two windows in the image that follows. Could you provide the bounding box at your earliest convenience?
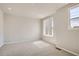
[0,3,79,56]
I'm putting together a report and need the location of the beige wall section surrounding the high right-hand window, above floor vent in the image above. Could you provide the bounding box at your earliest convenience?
[54,6,79,54]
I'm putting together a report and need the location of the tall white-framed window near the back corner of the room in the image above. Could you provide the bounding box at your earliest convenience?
[43,17,53,36]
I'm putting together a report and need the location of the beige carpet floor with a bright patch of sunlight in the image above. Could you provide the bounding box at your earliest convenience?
[0,40,73,56]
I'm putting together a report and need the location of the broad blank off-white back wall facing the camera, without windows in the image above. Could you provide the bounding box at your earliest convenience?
[4,14,41,43]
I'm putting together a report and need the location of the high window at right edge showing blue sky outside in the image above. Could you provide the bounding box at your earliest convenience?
[70,5,79,28]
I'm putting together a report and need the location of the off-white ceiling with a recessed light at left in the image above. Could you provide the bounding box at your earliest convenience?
[0,3,67,19]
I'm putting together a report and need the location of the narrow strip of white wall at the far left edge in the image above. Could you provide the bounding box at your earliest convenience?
[0,10,4,47]
